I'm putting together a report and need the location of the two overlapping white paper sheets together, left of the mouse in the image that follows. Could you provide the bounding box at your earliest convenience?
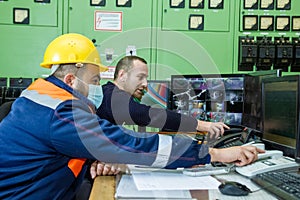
[116,168,220,200]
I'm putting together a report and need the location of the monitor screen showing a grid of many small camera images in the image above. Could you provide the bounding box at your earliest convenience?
[170,74,245,125]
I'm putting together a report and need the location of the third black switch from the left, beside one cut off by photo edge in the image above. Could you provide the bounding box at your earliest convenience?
[274,37,293,72]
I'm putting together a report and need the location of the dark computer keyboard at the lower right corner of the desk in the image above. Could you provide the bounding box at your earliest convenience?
[251,170,300,200]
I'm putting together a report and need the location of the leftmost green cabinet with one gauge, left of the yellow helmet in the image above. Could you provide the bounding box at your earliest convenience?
[0,0,63,78]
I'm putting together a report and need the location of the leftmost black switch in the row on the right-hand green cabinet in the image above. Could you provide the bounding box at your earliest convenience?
[239,36,257,71]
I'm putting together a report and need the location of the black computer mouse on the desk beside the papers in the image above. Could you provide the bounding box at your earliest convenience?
[219,181,251,196]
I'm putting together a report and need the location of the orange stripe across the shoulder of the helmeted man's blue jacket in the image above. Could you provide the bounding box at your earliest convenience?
[27,78,74,101]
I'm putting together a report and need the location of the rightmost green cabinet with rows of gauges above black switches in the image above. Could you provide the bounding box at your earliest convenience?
[234,0,300,74]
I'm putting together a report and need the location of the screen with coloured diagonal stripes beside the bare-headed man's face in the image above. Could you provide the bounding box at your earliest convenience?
[141,80,170,108]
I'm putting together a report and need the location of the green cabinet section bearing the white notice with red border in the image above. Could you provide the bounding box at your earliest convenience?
[67,0,154,71]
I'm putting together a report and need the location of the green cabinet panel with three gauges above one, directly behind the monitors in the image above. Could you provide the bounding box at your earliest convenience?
[156,0,235,79]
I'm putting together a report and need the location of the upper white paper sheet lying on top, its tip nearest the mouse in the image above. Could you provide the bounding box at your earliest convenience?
[132,171,220,190]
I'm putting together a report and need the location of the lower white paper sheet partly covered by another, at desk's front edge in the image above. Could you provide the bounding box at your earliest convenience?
[115,175,192,199]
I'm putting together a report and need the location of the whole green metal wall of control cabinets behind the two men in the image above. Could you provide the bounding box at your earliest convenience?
[0,0,300,83]
